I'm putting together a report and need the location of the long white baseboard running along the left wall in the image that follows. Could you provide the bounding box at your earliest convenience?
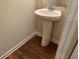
[0,31,37,59]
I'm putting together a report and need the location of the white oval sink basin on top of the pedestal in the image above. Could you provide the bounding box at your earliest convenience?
[35,8,62,21]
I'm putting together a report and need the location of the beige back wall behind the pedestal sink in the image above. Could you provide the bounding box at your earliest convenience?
[36,0,66,41]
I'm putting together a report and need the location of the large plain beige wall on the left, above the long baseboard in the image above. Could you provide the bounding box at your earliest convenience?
[0,0,35,56]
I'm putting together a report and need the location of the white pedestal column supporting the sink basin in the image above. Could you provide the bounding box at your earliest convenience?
[41,21,53,47]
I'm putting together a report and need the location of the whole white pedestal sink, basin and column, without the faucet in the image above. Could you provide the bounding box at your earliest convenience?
[35,8,62,47]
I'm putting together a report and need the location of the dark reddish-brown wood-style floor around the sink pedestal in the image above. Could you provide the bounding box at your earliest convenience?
[6,36,57,59]
